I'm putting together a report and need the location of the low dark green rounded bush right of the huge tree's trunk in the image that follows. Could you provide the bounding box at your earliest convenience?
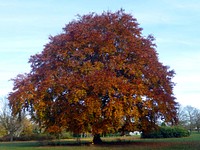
[141,126,190,138]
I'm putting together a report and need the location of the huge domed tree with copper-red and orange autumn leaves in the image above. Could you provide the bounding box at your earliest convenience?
[9,10,177,143]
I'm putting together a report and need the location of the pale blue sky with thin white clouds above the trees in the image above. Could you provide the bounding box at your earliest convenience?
[0,0,200,109]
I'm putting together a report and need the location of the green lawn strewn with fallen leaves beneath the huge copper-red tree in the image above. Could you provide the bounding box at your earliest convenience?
[0,133,200,150]
